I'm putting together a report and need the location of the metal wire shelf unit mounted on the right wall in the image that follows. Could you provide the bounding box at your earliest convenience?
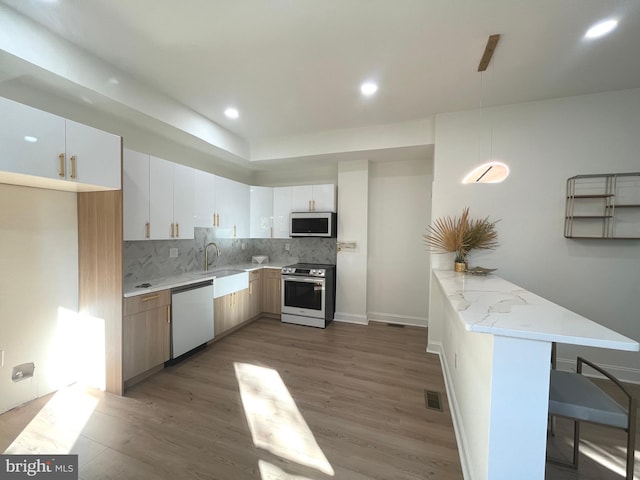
[564,173,640,240]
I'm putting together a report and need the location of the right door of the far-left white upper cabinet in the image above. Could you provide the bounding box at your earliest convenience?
[66,120,121,190]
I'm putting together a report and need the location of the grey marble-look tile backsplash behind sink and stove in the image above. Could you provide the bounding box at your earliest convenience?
[123,228,336,282]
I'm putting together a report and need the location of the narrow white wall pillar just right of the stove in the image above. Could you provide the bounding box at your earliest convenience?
[335,160,369,324]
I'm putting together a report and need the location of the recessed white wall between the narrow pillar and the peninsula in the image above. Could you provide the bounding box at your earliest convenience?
[367,158,433,326]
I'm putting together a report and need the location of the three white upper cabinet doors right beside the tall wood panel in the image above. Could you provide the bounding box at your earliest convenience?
[123,149,194,240]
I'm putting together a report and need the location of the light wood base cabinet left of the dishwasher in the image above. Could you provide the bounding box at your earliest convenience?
[122,290,171,381]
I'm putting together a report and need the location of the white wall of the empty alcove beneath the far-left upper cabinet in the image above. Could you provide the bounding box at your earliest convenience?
[0,185,83,413]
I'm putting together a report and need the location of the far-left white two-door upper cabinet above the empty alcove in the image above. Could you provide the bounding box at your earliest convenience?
[0,98,121,191]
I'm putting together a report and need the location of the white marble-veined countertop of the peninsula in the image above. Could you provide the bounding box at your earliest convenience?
[433,270,640,351]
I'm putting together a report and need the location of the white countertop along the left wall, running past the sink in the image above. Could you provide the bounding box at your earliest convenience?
[124,262,289,298]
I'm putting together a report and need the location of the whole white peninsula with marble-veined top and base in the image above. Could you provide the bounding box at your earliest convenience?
[428,270,640,480]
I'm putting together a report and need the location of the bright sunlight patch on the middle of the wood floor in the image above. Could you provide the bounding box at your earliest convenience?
[234,363,334,480]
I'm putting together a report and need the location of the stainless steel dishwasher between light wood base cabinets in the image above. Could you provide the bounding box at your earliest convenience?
[171,280,214,363]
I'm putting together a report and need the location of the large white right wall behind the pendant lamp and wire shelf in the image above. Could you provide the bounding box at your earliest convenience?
[432,89,640,382]
